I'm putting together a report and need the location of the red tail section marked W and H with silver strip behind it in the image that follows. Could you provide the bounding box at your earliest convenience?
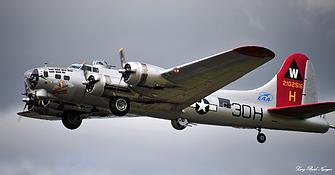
[276,53,317,107]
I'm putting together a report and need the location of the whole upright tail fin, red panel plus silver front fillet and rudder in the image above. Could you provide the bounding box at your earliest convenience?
[234,53,318,107]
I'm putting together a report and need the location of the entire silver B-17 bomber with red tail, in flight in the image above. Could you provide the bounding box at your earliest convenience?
[18,46,335,143]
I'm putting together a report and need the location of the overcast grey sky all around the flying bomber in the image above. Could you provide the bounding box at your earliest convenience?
[0,0,335,175]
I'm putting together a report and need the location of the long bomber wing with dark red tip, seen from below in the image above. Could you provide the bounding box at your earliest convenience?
[159,46,275,108]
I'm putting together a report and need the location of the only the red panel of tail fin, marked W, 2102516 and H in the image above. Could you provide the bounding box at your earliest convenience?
[276,53,309,107]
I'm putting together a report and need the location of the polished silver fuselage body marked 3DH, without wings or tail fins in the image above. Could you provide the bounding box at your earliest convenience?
[25,67,329,133]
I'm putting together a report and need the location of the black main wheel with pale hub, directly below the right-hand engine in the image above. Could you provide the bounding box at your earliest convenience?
[109,97,130,116]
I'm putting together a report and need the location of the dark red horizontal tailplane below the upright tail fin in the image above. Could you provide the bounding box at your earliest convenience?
[268,102,335,119]
